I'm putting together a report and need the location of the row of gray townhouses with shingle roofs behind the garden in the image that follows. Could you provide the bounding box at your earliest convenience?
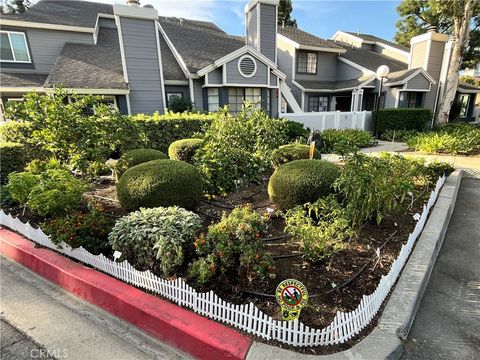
[0,0,479,121]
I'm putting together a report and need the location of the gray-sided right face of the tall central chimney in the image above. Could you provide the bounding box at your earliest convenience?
[257,4,277,62]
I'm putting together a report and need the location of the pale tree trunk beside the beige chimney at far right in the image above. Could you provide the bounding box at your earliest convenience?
[435,0,476,125]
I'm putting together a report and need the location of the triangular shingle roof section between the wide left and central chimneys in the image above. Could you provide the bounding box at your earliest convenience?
[159,17,245,73]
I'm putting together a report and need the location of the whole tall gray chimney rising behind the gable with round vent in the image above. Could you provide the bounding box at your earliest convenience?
[245,0,279,63]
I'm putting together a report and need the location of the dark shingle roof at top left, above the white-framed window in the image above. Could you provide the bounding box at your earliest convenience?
[2,0,113,28]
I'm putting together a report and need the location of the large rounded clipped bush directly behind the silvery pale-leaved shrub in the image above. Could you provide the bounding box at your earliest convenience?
[117,160,203,210]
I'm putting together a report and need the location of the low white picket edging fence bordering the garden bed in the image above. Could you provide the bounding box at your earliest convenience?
[0,177,445,346]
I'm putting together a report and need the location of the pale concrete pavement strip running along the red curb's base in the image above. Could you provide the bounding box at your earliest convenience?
[0,257,188,360]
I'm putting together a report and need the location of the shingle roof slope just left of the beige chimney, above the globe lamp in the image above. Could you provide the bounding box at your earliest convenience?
[341,45,408,72]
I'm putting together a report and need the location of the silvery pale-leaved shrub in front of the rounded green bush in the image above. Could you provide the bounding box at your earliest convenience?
[108,206,201,276]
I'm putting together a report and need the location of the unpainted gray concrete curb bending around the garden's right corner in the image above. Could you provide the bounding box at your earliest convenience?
[247,170,464,360]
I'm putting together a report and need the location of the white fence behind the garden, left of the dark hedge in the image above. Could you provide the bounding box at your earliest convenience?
[280,111,373,131]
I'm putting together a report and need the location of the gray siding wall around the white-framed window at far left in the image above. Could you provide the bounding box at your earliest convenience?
[2,26,93,74]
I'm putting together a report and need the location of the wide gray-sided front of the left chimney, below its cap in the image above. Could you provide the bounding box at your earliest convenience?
[120,18,165,114]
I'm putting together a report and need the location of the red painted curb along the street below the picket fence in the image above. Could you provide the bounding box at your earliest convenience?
[0,228,252,359]
